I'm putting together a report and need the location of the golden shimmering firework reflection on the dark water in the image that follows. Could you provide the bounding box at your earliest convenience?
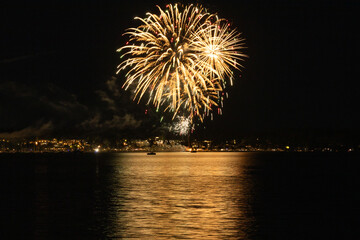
[112,153,254,239]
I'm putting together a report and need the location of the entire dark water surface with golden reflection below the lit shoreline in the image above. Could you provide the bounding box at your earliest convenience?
[0,153,359,239]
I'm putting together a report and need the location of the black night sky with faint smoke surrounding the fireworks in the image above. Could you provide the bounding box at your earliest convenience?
[0,0,360,142]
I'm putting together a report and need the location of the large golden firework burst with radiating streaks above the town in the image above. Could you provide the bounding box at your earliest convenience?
[117,4,245,122]
